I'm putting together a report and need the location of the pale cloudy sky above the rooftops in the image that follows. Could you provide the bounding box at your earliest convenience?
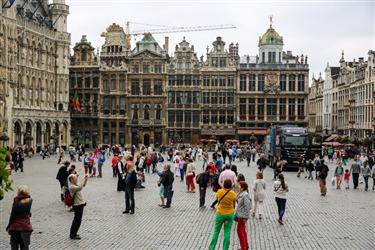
[66,0,375,78]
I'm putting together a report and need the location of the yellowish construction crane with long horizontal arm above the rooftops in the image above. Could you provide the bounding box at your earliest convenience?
[126,22,236,48]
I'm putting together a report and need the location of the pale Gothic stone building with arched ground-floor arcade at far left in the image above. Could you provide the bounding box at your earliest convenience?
[0,0,70,148]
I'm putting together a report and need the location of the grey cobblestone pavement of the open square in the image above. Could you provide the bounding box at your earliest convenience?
[0,153,375,250]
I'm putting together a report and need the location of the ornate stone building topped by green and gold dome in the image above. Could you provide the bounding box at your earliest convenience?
[236,25,309,141]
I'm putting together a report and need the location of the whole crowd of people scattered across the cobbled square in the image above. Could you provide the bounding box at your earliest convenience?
[7,144,375,249]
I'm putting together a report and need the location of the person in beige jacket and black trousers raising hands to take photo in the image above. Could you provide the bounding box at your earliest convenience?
[69,174,88,240]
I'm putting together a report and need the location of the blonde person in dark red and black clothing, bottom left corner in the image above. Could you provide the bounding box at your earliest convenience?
[6,185,33,250]
